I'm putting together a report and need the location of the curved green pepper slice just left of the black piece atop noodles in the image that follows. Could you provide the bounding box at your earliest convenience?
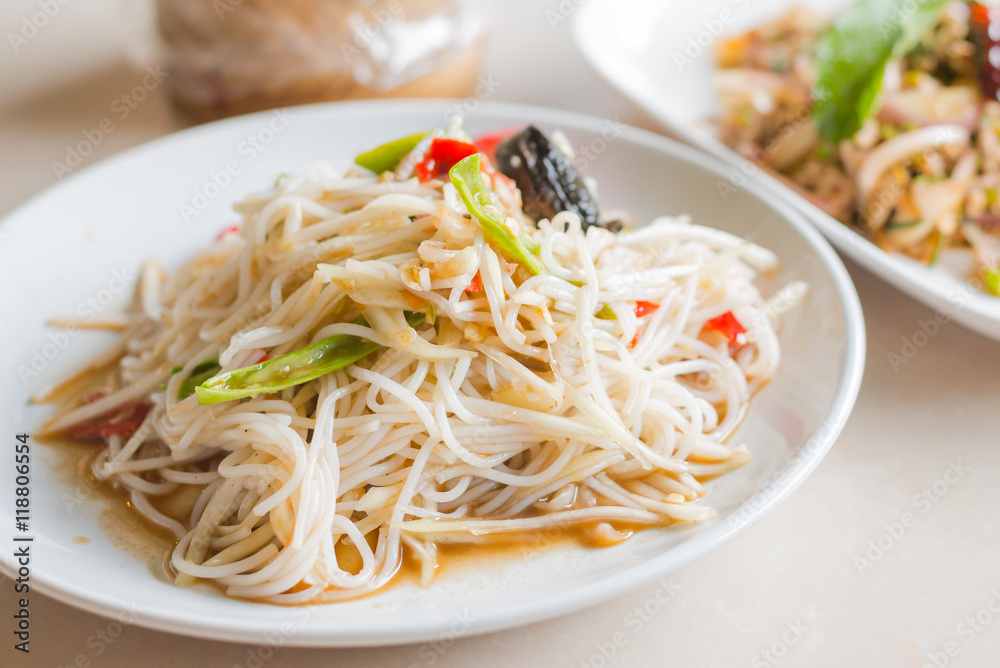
[448,153,547,276]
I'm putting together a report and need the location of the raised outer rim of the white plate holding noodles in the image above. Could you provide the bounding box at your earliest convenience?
[0,99,866,647]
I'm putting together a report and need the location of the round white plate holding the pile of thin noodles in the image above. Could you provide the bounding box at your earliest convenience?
[0,101,865,646]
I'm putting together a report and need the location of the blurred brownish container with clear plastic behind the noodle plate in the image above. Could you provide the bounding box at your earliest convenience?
[157,0,492,120]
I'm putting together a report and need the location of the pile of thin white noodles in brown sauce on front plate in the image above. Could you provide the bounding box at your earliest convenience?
[47,138,801,603]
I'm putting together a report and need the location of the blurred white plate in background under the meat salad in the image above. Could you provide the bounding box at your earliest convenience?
[573,0,1000,339]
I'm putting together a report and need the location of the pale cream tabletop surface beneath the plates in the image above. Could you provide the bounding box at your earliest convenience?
[0,0,1000,668]
